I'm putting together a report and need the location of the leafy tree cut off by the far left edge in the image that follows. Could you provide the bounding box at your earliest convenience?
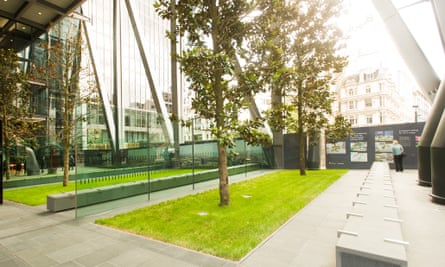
[0,49,33,179]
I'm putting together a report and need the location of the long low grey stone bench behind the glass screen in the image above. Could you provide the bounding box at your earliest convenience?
[46,163,260,212]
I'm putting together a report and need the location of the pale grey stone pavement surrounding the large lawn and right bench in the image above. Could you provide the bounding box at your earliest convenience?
[0,170,445,267]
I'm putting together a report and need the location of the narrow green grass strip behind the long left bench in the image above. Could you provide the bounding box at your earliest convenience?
[3,169,203,206]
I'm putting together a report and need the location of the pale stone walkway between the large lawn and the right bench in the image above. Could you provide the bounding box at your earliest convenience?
[241,170,368,267]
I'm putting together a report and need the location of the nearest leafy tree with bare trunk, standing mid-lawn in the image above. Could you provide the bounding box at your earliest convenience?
[155,0,269,206]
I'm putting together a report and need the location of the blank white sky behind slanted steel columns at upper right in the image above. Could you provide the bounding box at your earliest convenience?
[341,0,445,90]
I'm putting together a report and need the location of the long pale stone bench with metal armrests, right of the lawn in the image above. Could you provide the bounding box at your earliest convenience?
[336,162,408,267]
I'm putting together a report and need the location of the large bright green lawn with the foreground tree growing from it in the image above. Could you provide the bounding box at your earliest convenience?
[96,170,347,260]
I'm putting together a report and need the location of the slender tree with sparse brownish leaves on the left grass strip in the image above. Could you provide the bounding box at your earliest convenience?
[36,18,85,186]
